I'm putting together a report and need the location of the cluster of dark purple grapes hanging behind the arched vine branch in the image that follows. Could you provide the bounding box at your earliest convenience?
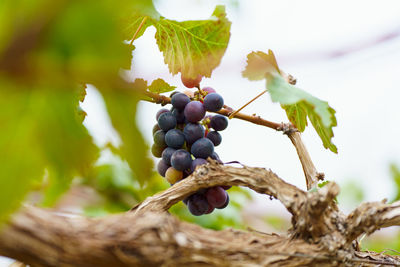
[151,87,230,216]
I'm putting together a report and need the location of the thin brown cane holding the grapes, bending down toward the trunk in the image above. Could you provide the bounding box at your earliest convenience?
[141,90,324,190]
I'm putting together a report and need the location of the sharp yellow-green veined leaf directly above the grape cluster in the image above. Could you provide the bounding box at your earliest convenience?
[155,6,231,78]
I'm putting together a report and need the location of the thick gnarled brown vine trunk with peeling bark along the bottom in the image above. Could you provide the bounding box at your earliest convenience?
[0,160,400,266]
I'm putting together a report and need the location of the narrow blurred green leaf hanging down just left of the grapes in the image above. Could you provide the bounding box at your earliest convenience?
[102,90,153,184]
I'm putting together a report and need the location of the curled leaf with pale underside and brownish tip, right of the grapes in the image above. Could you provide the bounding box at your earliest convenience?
[242,50,337,153]
